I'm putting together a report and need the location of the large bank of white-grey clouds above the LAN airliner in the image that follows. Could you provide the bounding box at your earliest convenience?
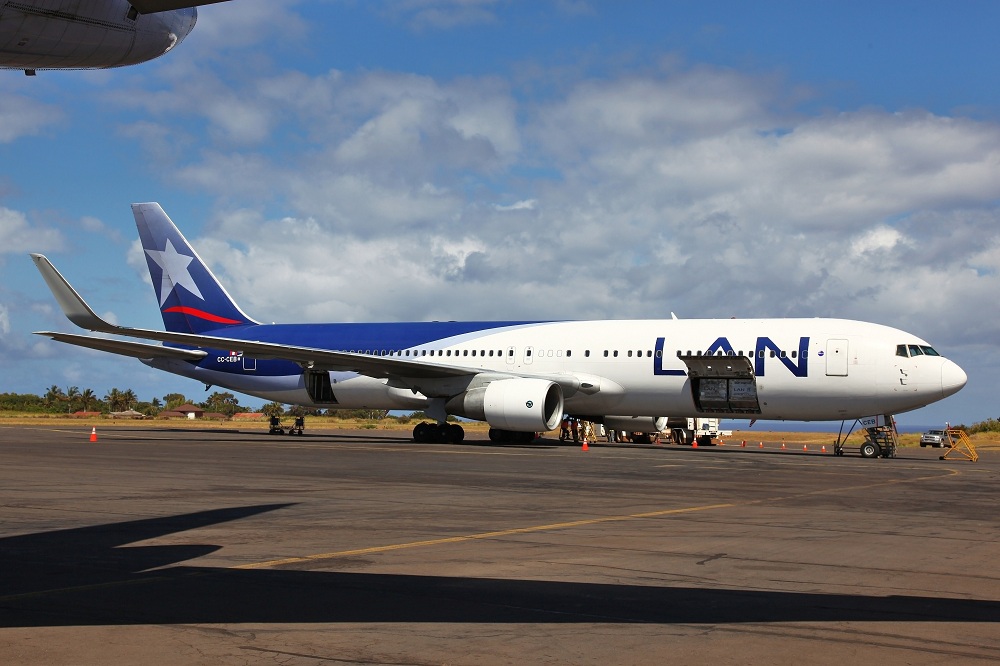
[105,60,1000,350]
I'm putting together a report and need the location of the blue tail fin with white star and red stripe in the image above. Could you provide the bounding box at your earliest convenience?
[132,203,258,333]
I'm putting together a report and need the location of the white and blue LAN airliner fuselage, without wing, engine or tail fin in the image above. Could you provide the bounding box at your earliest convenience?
[150,319,965,420]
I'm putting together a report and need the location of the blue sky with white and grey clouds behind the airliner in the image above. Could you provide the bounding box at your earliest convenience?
[0,0,1000,424]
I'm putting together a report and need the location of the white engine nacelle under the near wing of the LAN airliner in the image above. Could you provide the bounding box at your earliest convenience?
[445,378,563,432]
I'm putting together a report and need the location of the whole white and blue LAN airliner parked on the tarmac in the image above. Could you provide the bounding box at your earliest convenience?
[31,203,966,442]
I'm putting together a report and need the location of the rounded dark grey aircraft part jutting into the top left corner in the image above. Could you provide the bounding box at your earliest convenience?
[0,0,226,75]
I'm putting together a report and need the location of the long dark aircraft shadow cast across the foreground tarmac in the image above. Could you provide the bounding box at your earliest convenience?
[0,504,1000,627]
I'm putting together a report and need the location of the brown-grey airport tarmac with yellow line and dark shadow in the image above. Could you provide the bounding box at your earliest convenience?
[0,424,1000,666]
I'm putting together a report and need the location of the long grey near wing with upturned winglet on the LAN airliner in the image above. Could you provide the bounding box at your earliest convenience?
[31,254,596,392]
